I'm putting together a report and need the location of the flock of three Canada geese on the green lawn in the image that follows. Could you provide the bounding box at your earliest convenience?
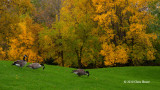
[12,55,89,76]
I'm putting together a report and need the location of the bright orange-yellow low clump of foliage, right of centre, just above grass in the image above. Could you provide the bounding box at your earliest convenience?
[100,43,128,66]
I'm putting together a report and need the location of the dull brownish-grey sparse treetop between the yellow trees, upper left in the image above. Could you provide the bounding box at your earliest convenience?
[31,0,63,28]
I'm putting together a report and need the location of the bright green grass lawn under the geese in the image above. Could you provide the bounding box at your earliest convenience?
[0,61,160,90]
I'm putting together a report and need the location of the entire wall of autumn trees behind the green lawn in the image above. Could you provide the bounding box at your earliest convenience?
[0,0,160,68]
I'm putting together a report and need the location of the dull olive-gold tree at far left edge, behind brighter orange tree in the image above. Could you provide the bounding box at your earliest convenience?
[0,0,33,59]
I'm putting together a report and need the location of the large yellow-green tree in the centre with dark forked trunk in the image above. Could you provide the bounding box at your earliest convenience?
[39,0,100,68]
